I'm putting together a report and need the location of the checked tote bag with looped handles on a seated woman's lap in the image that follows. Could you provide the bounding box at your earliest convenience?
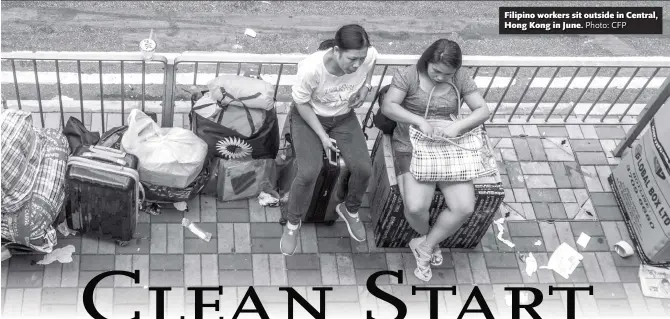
[409,83,497,182]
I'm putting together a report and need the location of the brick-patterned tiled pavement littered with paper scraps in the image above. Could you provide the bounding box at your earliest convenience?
[2,125,670,318]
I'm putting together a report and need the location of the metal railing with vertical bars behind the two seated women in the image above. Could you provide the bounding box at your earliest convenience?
[2,52,670,157]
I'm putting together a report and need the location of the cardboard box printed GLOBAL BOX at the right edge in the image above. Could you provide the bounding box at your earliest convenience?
[609,104,670,265]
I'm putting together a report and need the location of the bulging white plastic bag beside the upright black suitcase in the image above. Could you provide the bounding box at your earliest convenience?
[121,109,207,188]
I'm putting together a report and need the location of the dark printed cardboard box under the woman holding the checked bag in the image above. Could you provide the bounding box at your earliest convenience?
[370,133,505,248]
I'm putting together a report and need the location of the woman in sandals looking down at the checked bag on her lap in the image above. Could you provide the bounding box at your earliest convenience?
[381,39,489,281]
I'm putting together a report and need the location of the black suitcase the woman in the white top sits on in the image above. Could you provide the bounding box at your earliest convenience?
[279,112,350,225]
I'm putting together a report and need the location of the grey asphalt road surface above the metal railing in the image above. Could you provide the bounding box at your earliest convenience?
[1,1,670,56]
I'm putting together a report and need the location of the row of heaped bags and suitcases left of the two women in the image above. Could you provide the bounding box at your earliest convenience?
[0,76,279,258]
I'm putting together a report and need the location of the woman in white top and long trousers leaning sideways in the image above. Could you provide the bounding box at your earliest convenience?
[279,24,377,256]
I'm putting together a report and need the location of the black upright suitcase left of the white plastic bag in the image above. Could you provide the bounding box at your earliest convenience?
[65,146,142,242]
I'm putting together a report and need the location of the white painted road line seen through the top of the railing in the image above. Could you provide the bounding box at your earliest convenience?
[2,71,665,89]
